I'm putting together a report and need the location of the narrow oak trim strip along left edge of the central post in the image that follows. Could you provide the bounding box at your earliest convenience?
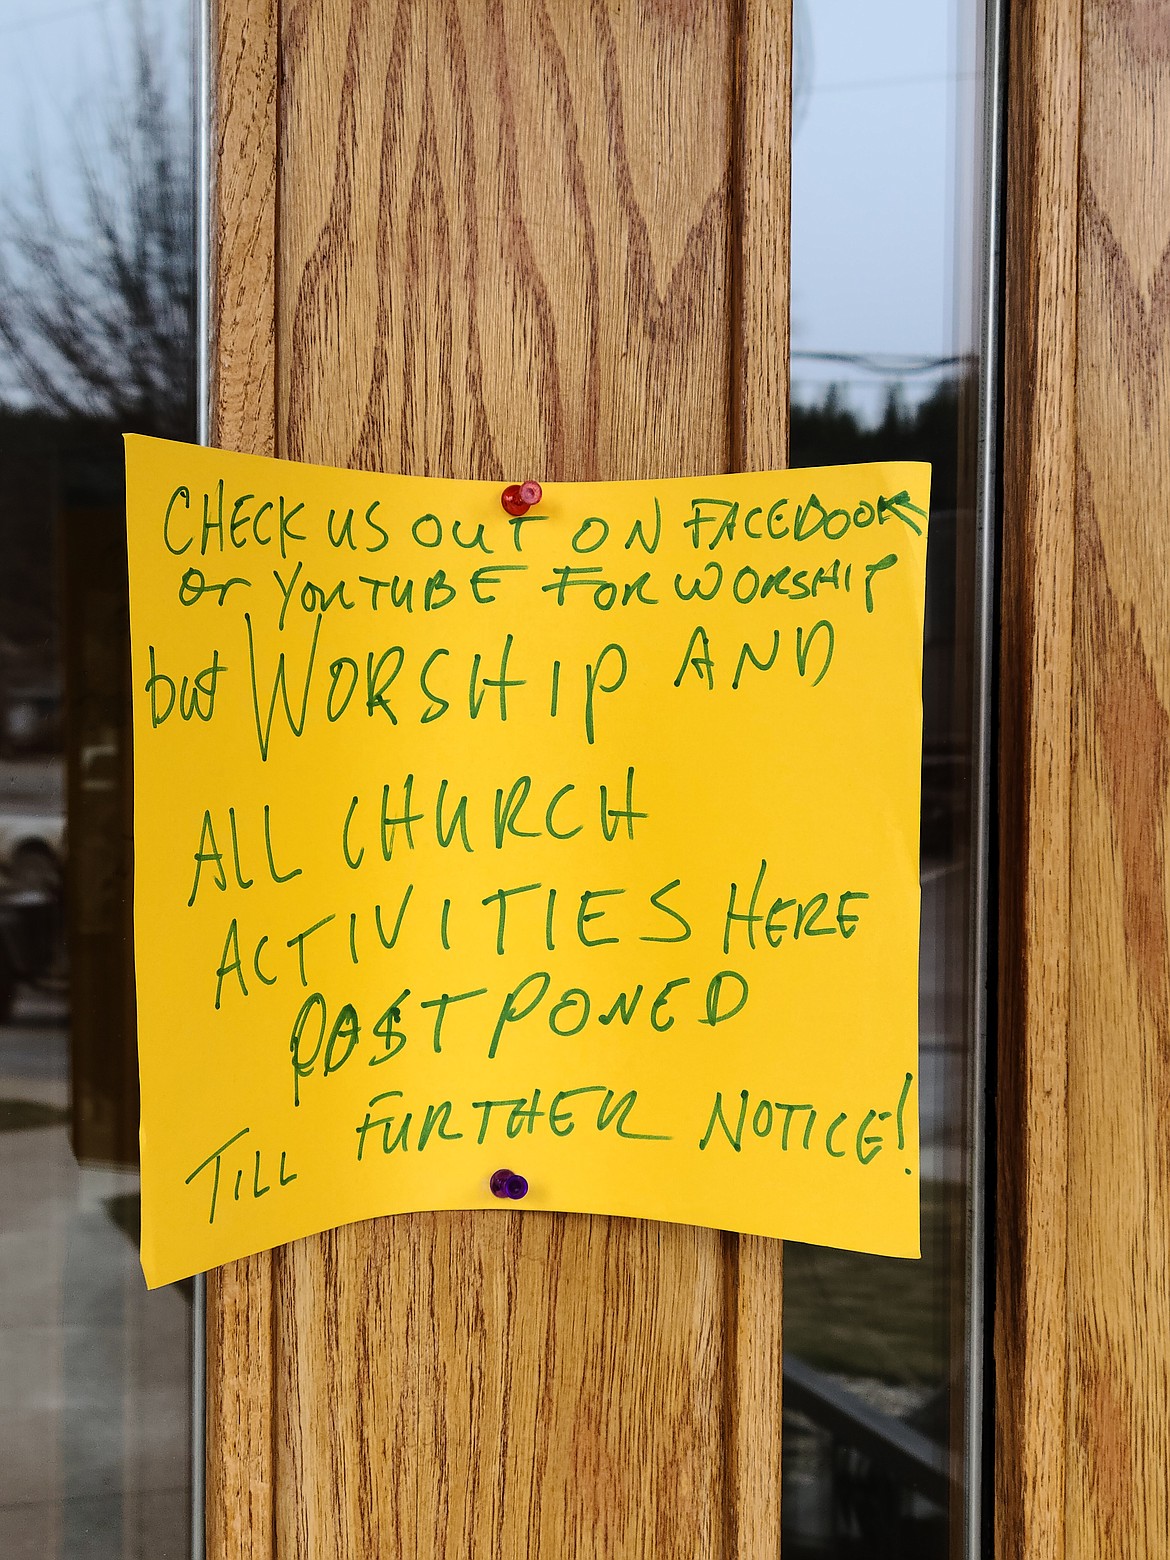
[206,0,276,1560]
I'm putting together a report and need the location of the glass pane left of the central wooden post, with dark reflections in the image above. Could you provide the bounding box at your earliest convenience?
[0,0,195,1560]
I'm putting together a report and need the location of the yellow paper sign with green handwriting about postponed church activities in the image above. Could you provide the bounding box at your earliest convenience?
[126,437,930,1284]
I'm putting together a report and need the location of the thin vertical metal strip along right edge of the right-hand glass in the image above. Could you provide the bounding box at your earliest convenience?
[964,0,1006,1560]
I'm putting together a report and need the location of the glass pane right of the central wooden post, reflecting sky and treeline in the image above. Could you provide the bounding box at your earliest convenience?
[783,0,984,1560]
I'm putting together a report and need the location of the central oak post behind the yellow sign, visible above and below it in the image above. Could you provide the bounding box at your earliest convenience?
[207,0,789,1560]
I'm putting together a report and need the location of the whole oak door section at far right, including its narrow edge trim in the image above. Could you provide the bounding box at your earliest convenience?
[997,0,1170,1560]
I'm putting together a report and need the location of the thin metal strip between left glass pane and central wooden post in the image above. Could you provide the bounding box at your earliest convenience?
[190,0,212,1560]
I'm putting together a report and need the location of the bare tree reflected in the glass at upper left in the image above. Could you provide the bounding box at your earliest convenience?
[0,8,195,435]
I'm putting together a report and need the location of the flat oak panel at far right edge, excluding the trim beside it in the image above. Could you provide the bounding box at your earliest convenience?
[1067,0,1170,1560]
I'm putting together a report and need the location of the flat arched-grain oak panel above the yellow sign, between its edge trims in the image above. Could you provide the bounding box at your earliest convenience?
[279,0,742,479]
